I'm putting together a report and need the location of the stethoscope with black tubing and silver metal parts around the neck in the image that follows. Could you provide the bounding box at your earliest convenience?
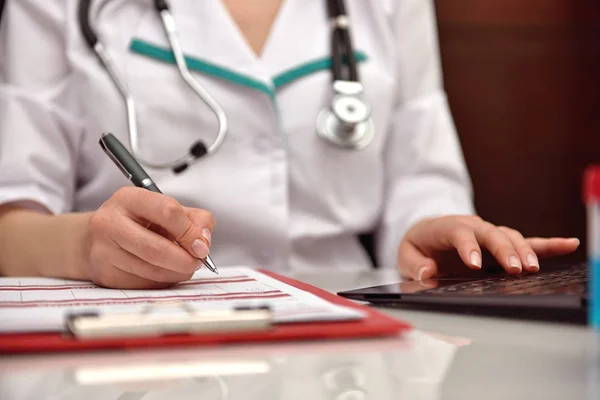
[78,0,375,174]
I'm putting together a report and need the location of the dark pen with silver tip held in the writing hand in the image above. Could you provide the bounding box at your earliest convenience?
[100,133,219,274]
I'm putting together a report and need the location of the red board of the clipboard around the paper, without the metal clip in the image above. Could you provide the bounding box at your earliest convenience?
[0,270,412,353]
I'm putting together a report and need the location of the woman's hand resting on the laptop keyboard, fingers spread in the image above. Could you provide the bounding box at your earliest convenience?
[398,216,579,280]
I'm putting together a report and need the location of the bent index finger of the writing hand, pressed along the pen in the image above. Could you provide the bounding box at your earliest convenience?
[115,188,209,258]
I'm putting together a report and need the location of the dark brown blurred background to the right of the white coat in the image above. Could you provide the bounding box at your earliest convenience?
[436,0,600,259]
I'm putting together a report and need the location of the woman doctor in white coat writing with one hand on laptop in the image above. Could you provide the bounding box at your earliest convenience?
[0,0,579,288]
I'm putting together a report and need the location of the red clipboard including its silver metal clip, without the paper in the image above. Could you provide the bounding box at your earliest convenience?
[0,270,412,354]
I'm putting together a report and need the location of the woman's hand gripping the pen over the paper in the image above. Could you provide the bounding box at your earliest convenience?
[84,187,215,289]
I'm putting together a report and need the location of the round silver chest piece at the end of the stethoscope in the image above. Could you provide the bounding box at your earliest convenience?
[317,81,375,150]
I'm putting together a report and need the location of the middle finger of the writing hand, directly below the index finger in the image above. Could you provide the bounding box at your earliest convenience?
[108,212,202,274]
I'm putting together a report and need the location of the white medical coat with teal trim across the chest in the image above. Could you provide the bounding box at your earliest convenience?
[0,0,473,272]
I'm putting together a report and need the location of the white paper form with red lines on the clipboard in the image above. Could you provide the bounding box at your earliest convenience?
[0,267,364,332]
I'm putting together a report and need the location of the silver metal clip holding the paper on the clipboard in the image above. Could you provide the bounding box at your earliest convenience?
[66,303,273,339]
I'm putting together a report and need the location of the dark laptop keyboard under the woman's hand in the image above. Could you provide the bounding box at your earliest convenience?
[427,264,588,295]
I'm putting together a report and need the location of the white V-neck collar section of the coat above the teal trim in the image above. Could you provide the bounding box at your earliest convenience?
[127,0,330,93]
